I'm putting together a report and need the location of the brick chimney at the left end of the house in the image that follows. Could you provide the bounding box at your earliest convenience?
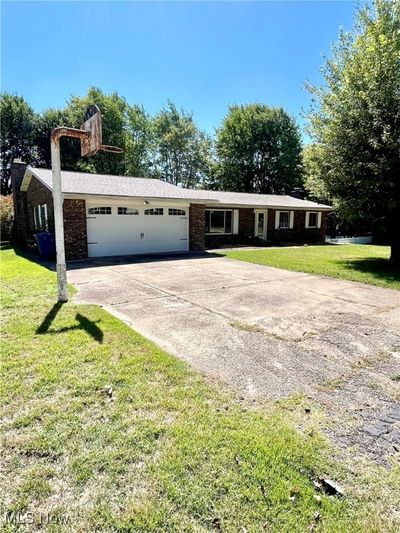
[10,159,28,245]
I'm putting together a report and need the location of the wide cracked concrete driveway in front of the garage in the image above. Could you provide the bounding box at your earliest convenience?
[68,254,400,458]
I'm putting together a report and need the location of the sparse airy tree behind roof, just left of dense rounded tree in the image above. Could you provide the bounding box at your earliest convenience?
[153,102,211,187]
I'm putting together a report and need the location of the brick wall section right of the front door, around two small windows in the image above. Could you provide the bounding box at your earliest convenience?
[267,209,327,244]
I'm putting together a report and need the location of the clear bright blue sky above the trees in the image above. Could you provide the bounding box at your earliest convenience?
[1,1,355,137]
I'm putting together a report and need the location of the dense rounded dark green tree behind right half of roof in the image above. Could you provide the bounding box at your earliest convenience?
[216,104,301,194]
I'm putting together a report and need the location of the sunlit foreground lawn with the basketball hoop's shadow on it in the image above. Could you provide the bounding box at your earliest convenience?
[0,248,395,532]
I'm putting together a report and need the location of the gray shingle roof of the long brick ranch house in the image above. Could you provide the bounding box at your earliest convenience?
[21,167,331,210]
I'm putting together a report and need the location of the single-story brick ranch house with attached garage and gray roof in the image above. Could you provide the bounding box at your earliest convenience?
[12,161,331,259]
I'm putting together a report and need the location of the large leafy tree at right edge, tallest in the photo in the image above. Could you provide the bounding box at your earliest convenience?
[309,0,400,265]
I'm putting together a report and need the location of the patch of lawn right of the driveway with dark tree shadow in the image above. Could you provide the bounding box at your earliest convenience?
[224,244,400,290]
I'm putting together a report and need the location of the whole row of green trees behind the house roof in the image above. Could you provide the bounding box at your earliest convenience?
[0,87,301,194]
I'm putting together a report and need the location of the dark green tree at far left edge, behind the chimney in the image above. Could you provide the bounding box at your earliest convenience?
[0,93,37,195]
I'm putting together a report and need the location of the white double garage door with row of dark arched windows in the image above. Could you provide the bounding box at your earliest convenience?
[86,203,189,257]
